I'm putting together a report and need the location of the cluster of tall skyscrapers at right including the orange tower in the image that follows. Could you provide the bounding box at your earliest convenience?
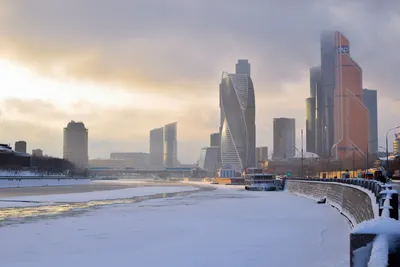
[306,31,378,160]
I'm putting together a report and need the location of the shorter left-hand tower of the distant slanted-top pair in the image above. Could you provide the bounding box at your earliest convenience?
[150,127,164,169]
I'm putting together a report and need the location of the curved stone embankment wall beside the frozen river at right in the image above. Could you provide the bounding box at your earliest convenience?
[286,180,377,225]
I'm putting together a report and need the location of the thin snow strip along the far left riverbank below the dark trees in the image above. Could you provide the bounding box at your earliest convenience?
[0,178,91,188]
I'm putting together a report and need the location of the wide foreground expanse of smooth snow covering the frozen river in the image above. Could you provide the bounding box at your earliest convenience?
[0,186,350,267]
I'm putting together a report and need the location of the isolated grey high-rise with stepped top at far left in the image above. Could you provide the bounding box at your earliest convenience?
[63,121,89,169]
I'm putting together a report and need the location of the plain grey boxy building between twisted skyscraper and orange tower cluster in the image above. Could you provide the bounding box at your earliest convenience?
[273,118,296,159]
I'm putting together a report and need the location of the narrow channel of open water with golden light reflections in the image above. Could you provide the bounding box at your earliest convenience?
[0,188,210,227]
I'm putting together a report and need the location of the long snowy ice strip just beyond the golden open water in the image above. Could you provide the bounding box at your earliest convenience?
[0,186,198,208]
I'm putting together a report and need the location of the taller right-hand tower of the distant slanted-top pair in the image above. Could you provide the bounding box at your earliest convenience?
[164,122,178,168]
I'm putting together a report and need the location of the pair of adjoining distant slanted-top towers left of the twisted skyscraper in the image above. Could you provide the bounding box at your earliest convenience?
[150,122,179,168]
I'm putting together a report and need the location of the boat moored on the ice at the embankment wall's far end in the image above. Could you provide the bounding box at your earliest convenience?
[244,168,281,191]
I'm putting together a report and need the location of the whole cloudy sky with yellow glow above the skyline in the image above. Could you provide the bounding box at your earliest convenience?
[0,0,400,163]
